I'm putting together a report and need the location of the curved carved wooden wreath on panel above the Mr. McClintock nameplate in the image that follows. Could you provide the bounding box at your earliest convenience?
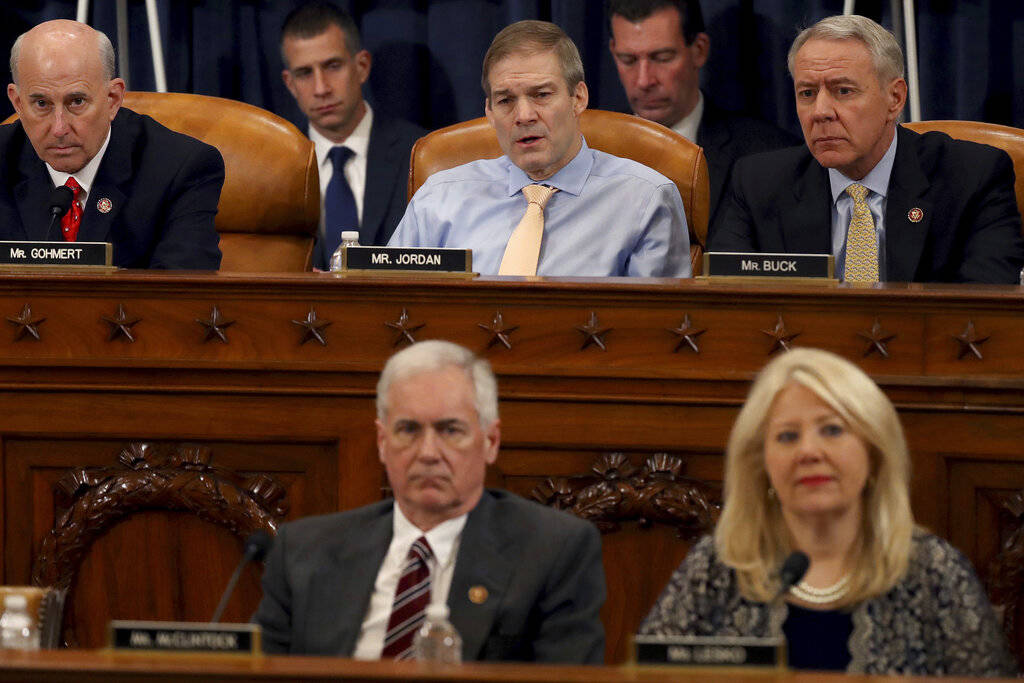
[32,442,288,646]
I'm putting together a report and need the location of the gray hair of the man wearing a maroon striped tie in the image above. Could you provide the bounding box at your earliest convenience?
[377,340,498,428]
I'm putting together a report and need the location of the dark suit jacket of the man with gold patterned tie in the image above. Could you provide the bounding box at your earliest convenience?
[710,126,1024,284]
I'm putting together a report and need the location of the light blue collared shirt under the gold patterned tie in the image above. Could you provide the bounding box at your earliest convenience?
[828,133,899,283]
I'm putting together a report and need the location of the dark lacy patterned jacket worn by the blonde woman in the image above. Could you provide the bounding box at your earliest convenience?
[640,532,1017,676]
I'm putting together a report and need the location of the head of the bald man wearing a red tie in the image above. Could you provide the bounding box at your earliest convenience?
[7,19,125,173]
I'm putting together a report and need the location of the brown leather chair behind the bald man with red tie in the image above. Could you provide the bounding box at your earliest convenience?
[5,92,319,272]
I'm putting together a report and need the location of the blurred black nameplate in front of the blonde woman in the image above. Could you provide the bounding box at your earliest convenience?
[633,636,786,669]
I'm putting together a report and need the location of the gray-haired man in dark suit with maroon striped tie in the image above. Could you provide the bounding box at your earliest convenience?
[255,341,605,664]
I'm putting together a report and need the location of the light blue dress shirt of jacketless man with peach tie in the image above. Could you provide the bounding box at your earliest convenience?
[389,140,690,278]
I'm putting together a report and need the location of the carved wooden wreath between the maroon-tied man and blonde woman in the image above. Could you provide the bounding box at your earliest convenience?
[532,453,722,540]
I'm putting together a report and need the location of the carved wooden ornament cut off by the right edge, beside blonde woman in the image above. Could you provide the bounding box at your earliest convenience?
[984,490,1024,663]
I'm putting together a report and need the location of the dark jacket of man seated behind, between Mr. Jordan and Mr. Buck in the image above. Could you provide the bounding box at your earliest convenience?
[696,95,801,233]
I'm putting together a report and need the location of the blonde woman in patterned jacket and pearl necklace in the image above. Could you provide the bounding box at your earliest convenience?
[640,349,1016,676]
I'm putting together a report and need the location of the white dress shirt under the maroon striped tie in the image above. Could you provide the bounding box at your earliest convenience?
[350,505,468,659]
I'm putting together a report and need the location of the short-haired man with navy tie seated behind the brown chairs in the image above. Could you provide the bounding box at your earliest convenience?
[281,2,425,270]
